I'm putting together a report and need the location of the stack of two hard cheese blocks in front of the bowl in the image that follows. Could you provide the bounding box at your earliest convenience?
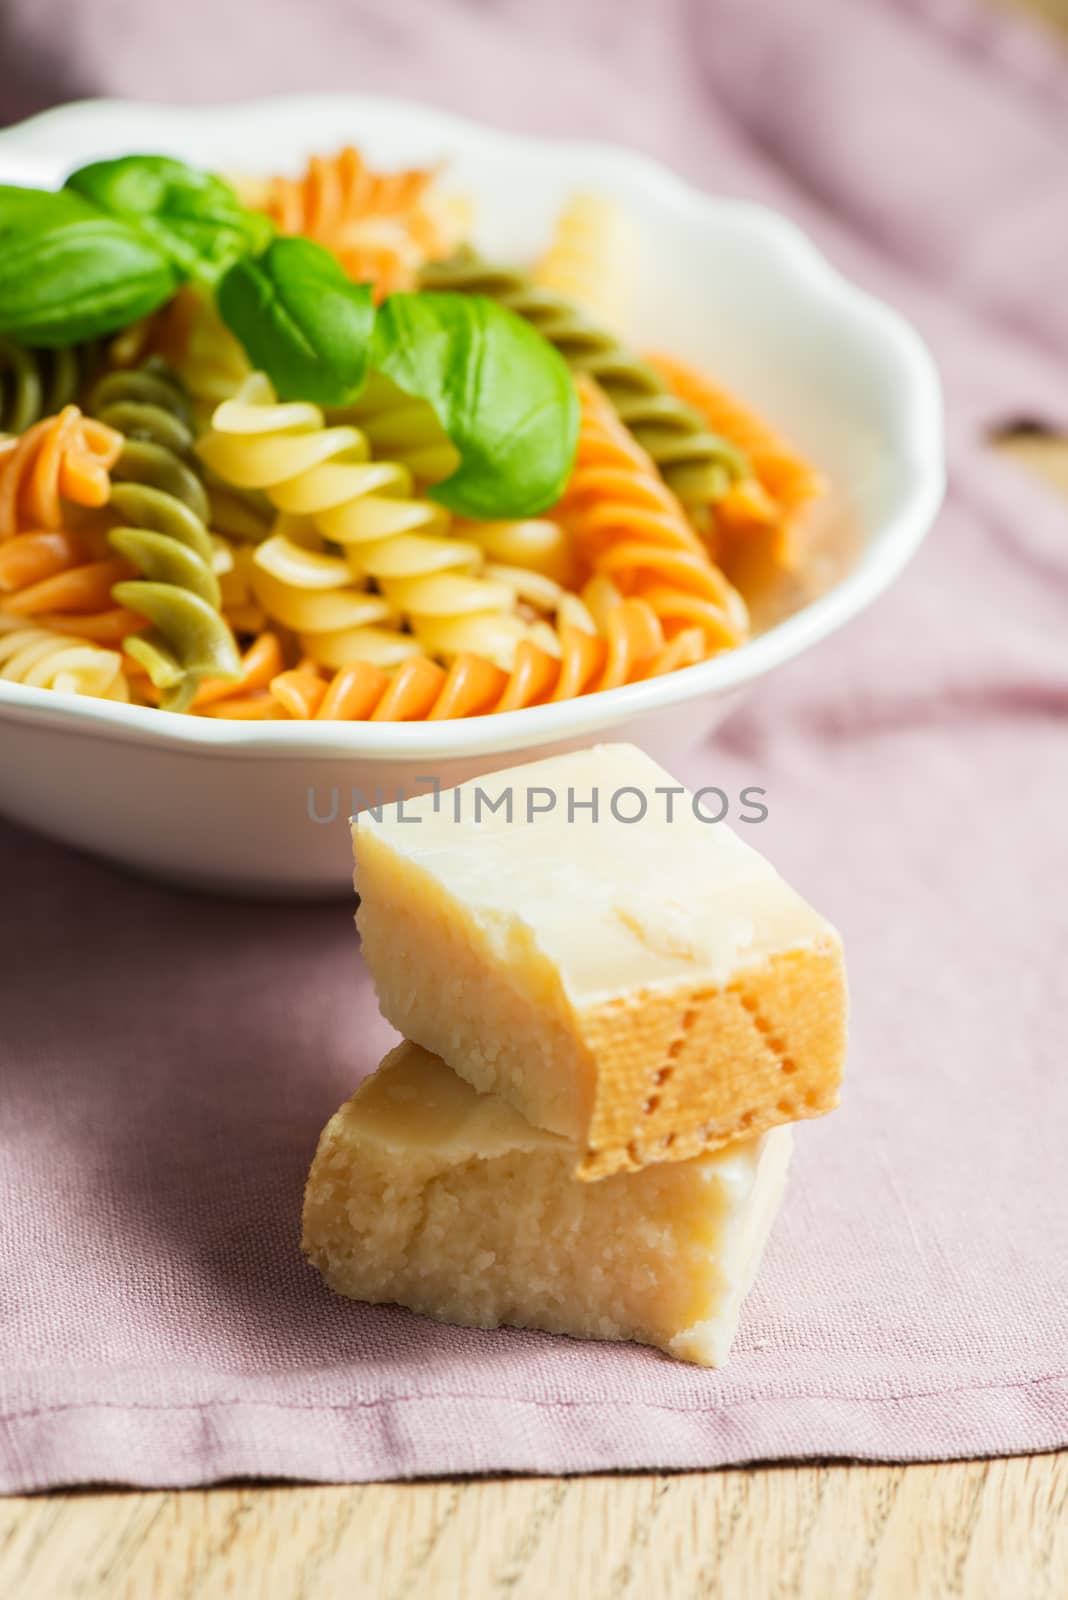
[304,744,846,1366]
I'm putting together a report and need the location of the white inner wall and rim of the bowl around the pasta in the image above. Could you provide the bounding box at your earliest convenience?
[0,96,942,749]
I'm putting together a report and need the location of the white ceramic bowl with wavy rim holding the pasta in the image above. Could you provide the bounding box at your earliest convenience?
[0,96,943,896]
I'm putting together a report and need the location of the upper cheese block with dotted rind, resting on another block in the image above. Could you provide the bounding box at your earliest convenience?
[353,744,846,1179]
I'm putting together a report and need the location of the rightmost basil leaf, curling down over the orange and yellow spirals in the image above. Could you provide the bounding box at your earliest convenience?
[373,293,579,518]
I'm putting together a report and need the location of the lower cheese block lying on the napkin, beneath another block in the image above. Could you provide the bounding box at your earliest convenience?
[304,1042,791,1366]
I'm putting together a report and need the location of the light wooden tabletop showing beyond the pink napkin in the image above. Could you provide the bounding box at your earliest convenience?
[0,0,1068,1600]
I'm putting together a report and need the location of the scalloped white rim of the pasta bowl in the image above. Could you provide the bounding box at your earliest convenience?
[0,94,945,760]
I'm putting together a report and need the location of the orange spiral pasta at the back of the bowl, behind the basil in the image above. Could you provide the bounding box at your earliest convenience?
[238,147,464,296]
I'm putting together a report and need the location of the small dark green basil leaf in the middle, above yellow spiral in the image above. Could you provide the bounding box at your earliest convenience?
[217,238,374,405]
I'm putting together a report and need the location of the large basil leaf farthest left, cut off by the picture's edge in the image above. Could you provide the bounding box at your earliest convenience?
[0,187,179,349]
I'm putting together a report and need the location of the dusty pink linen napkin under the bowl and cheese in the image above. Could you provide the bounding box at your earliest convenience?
[0,0,1068,1491]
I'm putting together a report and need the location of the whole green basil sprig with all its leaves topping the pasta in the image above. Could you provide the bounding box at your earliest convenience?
[0,155,579,517]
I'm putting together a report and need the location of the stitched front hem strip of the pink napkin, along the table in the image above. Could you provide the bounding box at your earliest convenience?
[0,1374,1068,1494]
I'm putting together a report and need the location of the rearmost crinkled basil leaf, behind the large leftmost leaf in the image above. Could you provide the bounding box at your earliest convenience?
[67,155,273,283]
